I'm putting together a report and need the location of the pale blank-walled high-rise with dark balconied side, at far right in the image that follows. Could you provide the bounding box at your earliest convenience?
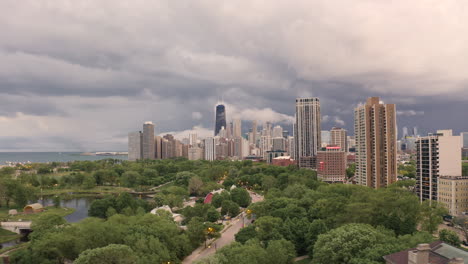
[416,130,462,201]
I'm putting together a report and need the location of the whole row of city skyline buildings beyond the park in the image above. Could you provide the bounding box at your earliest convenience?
[128,97,468,215]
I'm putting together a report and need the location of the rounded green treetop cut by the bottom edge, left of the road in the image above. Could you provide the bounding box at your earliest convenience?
[73,244,137,264]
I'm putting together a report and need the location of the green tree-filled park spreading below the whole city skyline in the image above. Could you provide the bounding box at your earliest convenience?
[0,159,461,264]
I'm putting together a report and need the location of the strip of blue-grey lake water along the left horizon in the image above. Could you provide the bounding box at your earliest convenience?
[0,152,128,165]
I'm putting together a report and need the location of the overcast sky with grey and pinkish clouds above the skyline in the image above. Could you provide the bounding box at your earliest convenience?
[0,0,468,151]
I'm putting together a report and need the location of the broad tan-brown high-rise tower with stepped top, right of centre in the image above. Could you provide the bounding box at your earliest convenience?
[354,97,397,188]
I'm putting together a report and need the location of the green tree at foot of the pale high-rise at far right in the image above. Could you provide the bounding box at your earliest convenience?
[421,200,448,234]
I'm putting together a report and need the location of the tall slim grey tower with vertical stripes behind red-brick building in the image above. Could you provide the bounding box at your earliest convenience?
[294,97,321,167]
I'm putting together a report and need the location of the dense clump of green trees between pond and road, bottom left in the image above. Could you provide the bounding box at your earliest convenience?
[12,214,201,263]
